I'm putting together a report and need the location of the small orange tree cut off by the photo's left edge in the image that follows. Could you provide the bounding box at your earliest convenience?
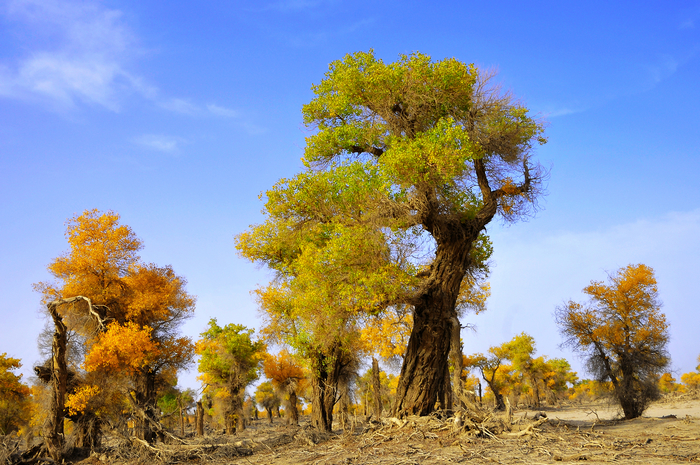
[0,353,31,435]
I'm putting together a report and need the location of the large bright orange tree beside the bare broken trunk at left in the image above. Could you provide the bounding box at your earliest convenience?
[35,210,195,441]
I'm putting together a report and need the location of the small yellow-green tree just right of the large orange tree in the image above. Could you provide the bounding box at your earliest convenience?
[196,318,265,434]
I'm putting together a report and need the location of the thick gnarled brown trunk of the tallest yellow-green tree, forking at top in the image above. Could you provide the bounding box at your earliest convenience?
[393,158,506,417]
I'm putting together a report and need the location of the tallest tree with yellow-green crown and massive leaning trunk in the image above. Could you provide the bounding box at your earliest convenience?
[238,51,544,416]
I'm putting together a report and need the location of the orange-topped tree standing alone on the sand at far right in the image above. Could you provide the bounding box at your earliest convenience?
[556,264,669,419]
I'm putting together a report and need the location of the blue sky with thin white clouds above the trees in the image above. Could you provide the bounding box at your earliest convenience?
[0,0,700,392]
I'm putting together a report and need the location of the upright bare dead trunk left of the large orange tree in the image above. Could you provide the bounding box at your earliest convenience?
[44,305,68,463]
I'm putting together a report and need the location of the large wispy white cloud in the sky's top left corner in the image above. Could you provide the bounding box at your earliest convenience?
[0,0,150,111]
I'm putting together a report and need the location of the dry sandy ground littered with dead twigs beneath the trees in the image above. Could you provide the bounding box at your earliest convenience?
[0,398,700,465]
